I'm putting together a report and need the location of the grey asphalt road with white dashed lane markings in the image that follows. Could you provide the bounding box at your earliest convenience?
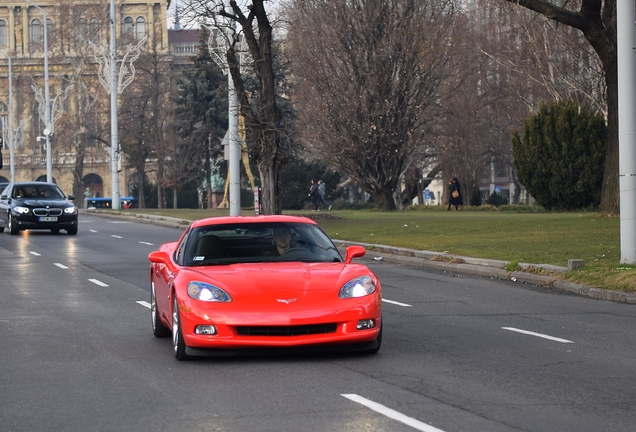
[0,214,636,432]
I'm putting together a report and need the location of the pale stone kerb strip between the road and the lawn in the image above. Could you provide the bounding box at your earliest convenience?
[87,209,636,304]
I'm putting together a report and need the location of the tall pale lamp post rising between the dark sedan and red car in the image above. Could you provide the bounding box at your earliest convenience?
[110,0,121,210]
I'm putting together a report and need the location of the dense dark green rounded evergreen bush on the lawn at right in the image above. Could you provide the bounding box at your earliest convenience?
[512,101,607,210]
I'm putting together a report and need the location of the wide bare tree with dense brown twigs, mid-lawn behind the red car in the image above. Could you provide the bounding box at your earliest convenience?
[288,0,454,210]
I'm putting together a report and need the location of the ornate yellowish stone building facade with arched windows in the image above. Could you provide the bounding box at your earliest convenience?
[0,0,175,204]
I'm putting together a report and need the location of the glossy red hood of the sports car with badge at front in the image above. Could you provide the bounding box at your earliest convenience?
[183,262,370,304]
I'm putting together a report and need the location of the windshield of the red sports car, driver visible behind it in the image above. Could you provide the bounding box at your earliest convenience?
[184,222,342,266]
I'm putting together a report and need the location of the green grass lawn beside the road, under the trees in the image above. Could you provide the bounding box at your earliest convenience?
[119,209,636,292]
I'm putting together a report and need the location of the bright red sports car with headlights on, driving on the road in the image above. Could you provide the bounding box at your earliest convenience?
[148,216,382,360]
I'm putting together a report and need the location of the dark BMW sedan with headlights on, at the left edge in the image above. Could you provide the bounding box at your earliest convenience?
[0,182,77,235]
